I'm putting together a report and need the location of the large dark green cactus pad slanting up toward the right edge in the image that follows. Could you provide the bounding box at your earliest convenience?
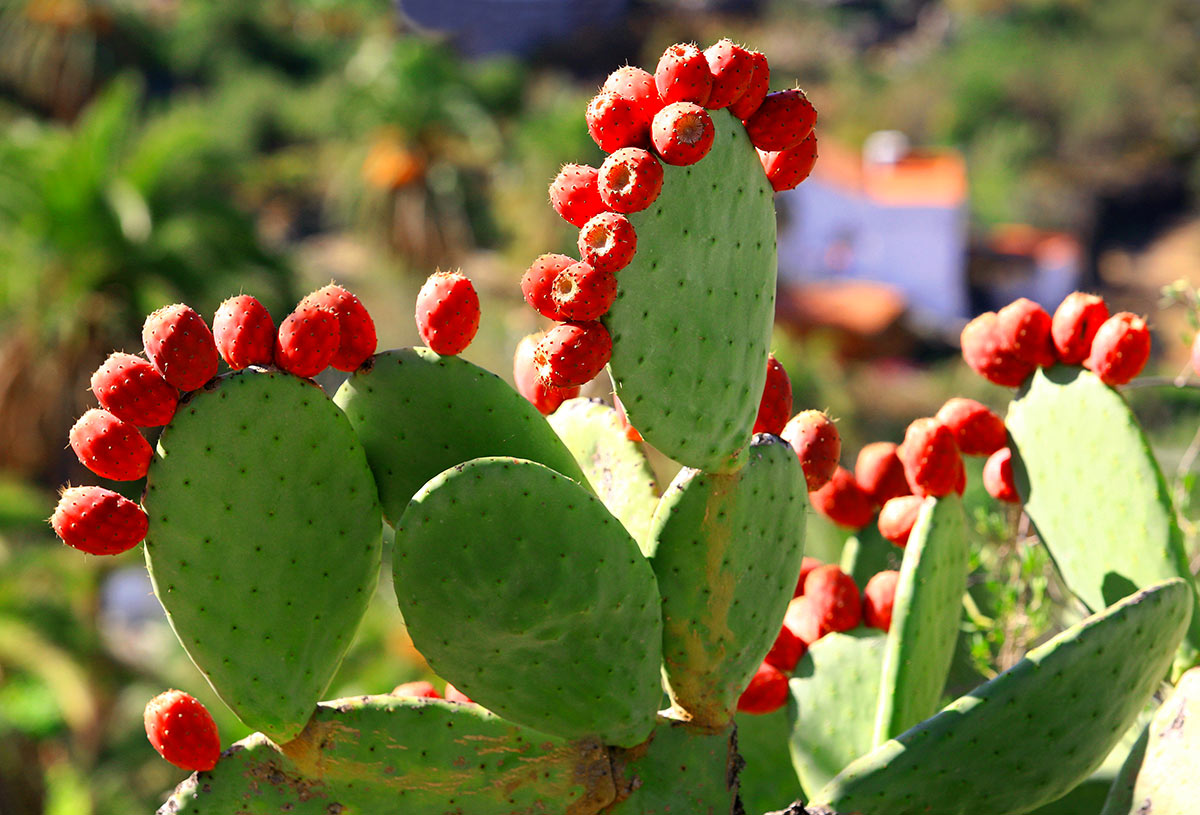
[809,577,1192,815]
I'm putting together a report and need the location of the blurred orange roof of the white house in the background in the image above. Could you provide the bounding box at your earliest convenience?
[812,143,967,206]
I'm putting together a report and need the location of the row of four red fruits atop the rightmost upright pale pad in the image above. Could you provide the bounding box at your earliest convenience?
[960,292,1150,388]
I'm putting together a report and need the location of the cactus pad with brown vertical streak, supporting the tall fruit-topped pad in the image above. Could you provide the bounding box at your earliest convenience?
[647,433,808,726]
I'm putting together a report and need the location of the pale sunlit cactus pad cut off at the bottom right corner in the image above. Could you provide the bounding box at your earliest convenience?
[1120,669,1200,815]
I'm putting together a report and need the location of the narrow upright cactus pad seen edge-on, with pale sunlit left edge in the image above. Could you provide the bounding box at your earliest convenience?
[872,495,970,747]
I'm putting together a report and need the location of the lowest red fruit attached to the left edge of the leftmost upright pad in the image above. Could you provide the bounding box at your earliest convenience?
[50,486,149,555]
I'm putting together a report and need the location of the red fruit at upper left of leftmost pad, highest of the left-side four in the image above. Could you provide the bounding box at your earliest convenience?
[142,302,220,390]
